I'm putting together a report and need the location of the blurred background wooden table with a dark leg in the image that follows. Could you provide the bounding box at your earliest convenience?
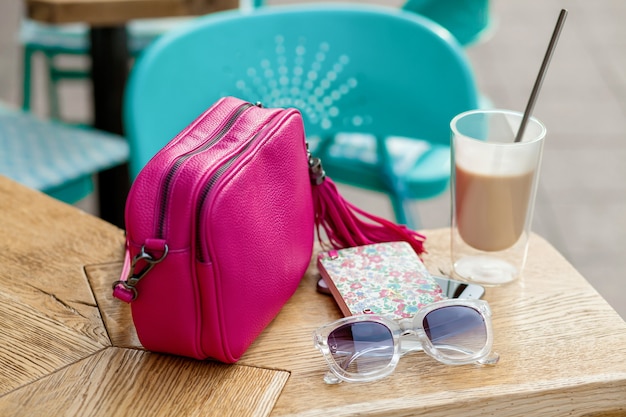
[24,0,239,228]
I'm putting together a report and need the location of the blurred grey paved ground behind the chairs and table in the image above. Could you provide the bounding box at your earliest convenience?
[0,0,626,318]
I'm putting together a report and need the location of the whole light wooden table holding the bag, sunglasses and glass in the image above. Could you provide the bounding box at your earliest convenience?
[0,177,626,417]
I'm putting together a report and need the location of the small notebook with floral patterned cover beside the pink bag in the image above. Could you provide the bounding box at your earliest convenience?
[318,242,446,319]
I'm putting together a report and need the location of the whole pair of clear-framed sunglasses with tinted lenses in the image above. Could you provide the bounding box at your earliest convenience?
[313,299,499,384]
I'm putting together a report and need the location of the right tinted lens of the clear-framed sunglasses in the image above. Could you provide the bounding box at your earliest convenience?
[423,306,487,359]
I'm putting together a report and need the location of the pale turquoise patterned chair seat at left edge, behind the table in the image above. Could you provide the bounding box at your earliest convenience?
[0,105,128,203]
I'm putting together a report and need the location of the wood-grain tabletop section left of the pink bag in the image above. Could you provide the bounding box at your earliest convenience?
[0,180,123,392]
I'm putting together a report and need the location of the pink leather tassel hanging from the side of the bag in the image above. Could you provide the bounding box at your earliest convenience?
[313,174,426,255]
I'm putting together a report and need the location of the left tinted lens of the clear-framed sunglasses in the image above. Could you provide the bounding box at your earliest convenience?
[328,321,393,374]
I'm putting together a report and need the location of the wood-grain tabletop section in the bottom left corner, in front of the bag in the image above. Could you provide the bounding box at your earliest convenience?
[0,348,289,416]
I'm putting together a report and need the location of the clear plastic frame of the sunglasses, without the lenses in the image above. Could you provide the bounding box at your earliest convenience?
[313,299,500,384]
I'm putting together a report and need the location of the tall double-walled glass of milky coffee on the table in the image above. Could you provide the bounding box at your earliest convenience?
[450,110,546,285]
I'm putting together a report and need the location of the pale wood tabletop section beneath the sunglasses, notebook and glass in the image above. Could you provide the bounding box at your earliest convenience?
[88,230,626,416]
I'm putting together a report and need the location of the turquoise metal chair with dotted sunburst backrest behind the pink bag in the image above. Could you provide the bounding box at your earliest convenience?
[124,3,478,226]
